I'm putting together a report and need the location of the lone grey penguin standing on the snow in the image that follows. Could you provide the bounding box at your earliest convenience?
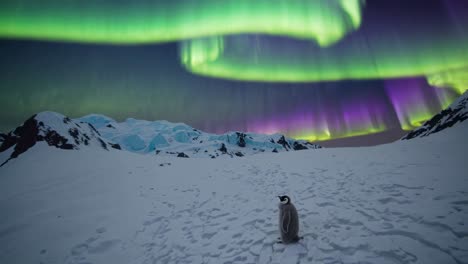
[278,195,300,244]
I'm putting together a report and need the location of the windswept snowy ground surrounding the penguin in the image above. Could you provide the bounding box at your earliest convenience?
[0,122,468,264]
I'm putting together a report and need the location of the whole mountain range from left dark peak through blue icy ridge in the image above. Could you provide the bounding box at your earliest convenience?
[0,111,320,166]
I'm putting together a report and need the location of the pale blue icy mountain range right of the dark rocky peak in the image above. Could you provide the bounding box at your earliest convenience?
[76,114,320,158]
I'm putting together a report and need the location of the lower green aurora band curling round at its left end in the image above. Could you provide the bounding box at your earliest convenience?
[180,35,468,93]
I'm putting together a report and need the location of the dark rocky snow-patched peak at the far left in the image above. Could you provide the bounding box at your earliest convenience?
[0,112,120,166]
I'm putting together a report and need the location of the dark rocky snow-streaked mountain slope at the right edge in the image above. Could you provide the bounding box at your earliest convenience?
[402,91,468,140]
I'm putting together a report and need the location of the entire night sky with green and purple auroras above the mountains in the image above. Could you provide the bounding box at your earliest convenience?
[0,0,468,146]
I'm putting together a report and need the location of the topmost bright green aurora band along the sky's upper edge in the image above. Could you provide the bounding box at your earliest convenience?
[0,0,364,47]
